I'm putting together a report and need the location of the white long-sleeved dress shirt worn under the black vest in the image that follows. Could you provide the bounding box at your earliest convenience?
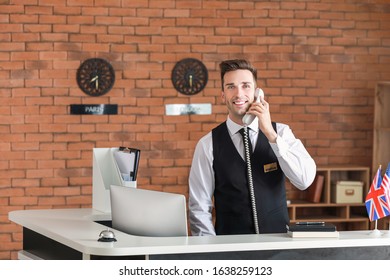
[189,117,316,235]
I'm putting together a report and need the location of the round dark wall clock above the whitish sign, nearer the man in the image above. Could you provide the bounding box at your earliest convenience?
[171,58,208,95]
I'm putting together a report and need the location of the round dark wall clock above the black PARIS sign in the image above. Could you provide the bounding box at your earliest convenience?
[76,58,115,96]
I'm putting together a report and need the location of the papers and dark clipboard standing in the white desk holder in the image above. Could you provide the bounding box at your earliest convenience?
[114,147,140,182]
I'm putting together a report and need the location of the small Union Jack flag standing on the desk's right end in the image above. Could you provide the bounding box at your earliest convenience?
[366,167,390,221]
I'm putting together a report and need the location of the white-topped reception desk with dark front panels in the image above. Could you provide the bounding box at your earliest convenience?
[9,208,390,260]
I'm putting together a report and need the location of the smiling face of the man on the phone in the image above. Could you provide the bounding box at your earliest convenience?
[222,70,256,124]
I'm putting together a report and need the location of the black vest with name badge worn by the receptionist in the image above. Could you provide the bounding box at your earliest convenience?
[212,122,289,234]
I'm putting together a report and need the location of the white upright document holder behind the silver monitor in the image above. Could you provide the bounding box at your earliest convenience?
[92,148,139,213]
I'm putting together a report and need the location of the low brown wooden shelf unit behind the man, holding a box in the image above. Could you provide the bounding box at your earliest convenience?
[288,166,370,230]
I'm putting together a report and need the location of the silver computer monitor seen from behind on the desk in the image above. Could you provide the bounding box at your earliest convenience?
[110,185,188,237]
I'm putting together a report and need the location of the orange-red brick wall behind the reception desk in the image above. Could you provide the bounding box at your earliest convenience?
[0,0,390,259]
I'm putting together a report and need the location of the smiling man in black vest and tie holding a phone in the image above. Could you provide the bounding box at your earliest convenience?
[189,60,316,235]
